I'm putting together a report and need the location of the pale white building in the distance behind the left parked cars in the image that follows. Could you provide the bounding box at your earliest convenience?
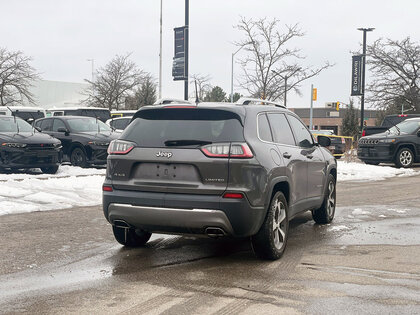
[25,80,89,109]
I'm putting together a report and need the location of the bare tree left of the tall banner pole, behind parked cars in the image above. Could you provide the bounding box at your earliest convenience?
[86,54,145,110]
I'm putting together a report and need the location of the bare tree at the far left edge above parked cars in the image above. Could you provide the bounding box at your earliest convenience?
[0,48,39,106]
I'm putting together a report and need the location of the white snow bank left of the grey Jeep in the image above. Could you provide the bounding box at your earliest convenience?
[0,165,105,215]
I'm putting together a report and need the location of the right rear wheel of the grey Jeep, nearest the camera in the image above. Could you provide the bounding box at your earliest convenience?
[251,192,289,260]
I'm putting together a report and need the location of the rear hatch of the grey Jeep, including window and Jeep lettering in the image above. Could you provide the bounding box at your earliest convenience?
[108,106,249,195]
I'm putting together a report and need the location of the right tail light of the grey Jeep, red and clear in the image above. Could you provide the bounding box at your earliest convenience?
[201,143,254,159]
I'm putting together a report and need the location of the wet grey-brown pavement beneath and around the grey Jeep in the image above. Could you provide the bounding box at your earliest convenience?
[0,177,420,314]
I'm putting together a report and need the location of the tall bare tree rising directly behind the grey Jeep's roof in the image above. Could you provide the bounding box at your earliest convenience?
[236,18,331,100]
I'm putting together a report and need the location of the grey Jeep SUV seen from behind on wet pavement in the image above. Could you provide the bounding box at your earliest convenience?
[103,99,337,259]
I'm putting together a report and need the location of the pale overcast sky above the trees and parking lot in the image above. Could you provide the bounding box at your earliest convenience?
[0,0,420,107]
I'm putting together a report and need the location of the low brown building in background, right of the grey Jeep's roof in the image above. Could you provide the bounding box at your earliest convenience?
[289,107,377,135]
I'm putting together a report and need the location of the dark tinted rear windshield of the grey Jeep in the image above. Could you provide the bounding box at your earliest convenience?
[120,108,244,147]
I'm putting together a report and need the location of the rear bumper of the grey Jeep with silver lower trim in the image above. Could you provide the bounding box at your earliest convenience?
[103,189,266,237]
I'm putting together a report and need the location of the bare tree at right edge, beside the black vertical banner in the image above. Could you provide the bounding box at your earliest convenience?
[366,37,420,111]
